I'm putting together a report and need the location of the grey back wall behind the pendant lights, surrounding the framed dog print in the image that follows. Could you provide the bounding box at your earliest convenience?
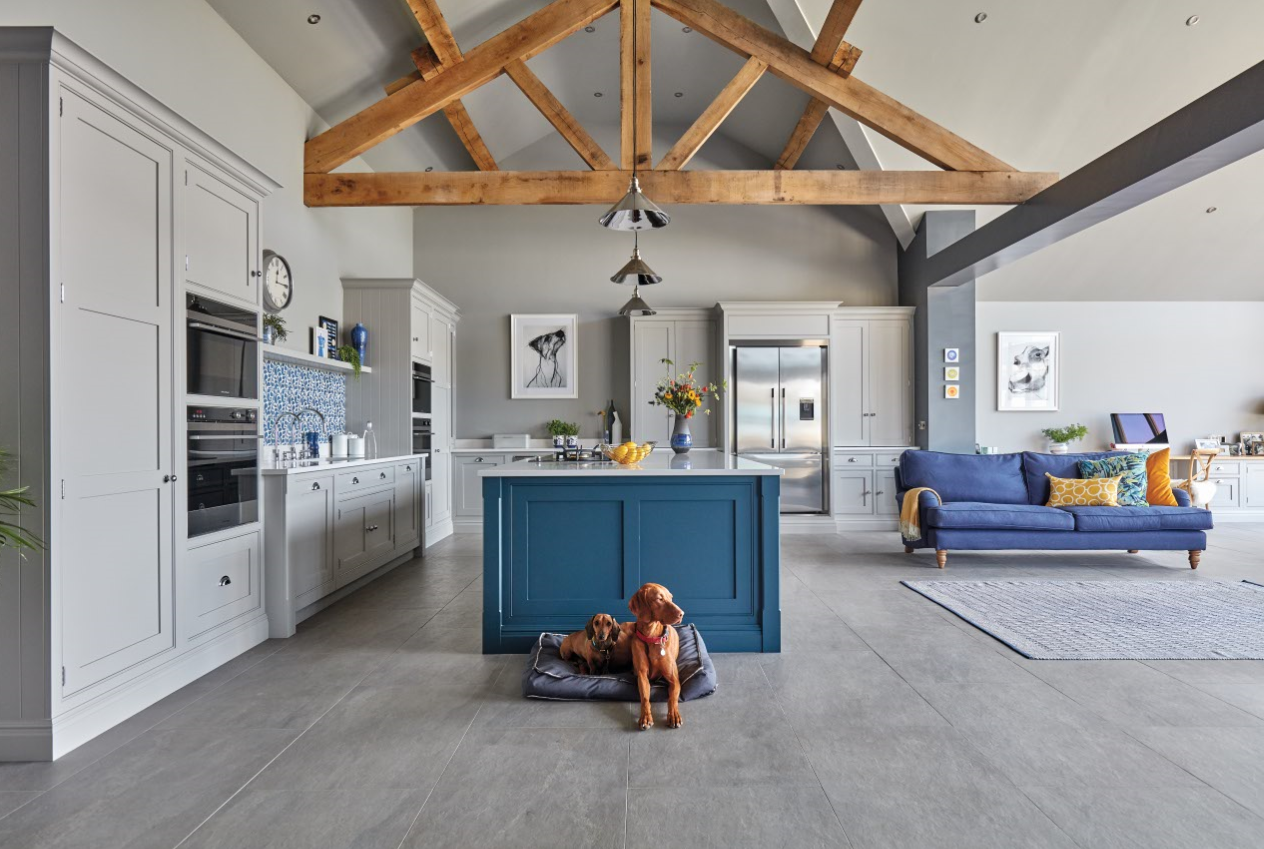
[413,139,896,438]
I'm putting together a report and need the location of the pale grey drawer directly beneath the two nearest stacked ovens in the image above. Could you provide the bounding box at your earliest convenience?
[181,532,263,637]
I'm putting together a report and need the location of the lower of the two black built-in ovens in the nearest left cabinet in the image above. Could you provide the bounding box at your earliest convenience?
[187,407,260,537]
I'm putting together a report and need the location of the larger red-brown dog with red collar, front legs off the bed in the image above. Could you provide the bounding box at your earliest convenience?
[617,584,685,732]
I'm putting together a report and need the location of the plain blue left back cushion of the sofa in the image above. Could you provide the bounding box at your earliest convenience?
[900,451,1028,504]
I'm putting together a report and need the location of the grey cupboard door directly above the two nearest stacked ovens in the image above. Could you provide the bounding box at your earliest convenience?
[183,158,260,306]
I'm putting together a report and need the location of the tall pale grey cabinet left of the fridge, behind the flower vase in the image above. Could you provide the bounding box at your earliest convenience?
[623,310,724,449]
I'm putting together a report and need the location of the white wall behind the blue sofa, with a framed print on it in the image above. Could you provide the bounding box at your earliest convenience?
[976,301,1264,451]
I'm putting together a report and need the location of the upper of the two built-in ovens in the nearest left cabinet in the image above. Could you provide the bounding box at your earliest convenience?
[185,294,259,398]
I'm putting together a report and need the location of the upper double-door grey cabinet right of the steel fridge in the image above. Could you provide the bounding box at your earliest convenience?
[829,307,913,446]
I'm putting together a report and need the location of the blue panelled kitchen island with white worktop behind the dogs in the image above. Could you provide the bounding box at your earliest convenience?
[480,451,782,654]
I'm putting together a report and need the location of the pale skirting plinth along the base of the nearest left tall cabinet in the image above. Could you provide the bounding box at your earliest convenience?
[14,615,268,762]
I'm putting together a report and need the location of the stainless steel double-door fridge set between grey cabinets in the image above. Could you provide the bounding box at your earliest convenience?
[733,345,829,513]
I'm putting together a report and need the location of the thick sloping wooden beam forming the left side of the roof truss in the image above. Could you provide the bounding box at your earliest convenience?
[305,0,618,173]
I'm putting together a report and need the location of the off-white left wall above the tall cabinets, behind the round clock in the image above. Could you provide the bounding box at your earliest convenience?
[0,0,412,338]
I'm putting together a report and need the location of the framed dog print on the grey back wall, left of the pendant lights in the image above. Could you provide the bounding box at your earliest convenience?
[509,313,579,399]
